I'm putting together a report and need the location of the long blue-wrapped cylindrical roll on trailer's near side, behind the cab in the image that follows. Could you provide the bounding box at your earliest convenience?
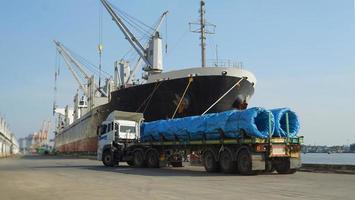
[141,107,274,142]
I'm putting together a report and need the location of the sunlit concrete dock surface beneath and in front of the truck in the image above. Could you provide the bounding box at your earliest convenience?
[0,156,355,200]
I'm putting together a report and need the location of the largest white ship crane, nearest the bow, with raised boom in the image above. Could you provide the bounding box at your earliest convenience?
[101,0,168,74]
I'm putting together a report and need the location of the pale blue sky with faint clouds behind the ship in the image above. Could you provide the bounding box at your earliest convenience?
[0,0,355,145]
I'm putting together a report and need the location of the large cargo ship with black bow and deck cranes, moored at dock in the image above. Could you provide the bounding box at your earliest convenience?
[54,0,256,153]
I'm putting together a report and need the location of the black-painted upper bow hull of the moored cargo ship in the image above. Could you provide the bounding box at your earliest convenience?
[109,76,254,121]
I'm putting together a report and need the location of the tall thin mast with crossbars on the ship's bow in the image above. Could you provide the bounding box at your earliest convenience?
[189,0,216,67]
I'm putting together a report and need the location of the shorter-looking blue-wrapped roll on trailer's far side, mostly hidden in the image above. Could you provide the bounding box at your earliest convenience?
[271,108,300,137]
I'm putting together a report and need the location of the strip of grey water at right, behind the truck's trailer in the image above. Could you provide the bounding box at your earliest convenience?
[301,153,355,165]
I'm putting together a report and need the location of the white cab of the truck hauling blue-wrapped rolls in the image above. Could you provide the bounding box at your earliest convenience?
[97,111,143,165]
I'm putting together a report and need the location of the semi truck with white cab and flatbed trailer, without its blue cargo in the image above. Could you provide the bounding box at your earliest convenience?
[97,111,303,175]
